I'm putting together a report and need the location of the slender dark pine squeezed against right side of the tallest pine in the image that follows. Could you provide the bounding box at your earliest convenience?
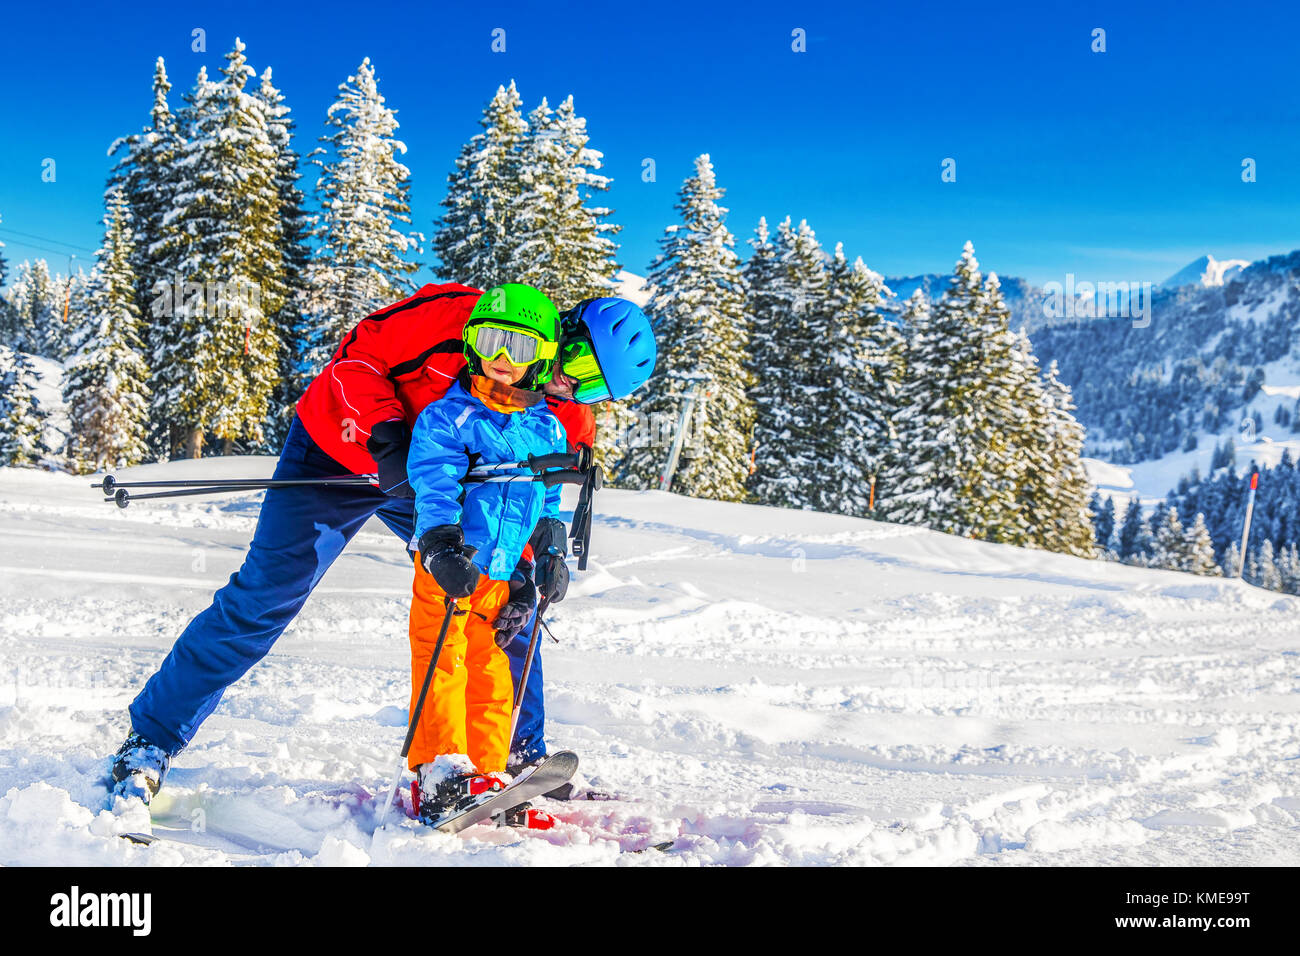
[257,66,311,450]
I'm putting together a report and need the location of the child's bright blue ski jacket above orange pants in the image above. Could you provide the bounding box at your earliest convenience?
[407,381,567,581]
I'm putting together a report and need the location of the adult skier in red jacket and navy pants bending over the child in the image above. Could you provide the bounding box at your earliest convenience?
[113,284,655,801]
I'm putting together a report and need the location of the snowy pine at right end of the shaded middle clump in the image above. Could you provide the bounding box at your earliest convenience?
[811,243,905,515]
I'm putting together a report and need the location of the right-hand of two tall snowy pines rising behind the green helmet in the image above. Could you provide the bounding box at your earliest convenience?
[508,96,619,308]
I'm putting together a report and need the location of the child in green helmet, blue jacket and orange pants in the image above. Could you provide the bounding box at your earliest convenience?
[407,284,566,822]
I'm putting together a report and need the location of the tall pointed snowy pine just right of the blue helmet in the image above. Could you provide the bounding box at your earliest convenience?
[620,153,754,501]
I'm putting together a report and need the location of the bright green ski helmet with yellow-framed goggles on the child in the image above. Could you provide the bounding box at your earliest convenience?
[462,282,560,389]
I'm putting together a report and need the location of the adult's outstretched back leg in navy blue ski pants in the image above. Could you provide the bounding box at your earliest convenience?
[130,419,386,754]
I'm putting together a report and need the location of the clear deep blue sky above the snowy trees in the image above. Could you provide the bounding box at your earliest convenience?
[0,0,1300,291]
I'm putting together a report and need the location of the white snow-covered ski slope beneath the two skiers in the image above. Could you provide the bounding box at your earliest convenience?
[0,458,1300,866]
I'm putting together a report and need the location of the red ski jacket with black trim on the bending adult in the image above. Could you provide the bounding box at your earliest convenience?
[298,282,595,473]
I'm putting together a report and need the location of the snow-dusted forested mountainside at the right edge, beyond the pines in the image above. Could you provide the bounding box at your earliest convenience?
[1030,250,1300,464]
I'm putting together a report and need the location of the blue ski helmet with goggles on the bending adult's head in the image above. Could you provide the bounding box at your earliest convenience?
[560,298,659,405]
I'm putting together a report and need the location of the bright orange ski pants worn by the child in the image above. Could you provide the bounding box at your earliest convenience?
[407,558,515,774]
